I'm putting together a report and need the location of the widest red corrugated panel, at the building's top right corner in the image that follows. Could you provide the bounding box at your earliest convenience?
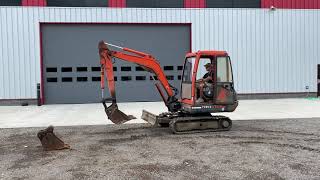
[261,0,320,9]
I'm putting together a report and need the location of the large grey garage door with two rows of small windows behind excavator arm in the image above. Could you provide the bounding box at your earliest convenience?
[41,24,190,104]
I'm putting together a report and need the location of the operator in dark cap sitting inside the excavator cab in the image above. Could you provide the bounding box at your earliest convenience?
[196,63,214,103]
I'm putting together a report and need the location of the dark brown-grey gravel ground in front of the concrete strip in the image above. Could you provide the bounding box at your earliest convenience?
[0,118,320,179]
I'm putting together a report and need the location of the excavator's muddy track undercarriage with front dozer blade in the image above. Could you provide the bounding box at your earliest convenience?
[141,110,232,134]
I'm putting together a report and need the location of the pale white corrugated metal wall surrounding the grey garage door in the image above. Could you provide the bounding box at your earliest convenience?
[0,7,320,99]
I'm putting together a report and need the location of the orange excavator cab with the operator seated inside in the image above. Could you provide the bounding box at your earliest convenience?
[181,51,238,114]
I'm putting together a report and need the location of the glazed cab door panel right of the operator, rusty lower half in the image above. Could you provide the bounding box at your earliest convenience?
[215,56,236,105]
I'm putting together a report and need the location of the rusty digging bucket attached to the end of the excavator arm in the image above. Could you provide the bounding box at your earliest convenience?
[102,102,136,124]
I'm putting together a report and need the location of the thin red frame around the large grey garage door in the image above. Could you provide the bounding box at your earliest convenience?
[39,22,192,105]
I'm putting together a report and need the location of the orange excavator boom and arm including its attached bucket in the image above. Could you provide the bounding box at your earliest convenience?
[99,41,181,124]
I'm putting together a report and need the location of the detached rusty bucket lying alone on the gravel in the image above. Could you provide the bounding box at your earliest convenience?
[37,126,70,151]
